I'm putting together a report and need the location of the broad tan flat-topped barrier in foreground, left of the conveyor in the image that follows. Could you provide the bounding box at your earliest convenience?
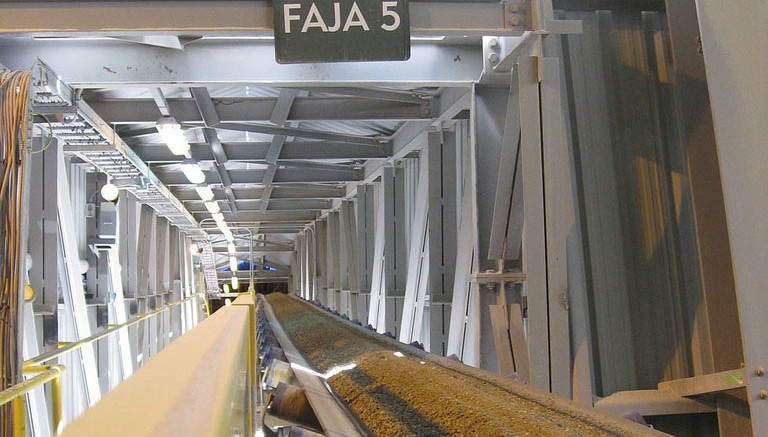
[62,301,255,437]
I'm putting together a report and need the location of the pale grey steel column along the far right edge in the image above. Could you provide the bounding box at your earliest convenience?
[696,0,768,430]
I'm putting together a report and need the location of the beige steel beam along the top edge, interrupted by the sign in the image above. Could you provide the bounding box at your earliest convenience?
[0,0,531,36]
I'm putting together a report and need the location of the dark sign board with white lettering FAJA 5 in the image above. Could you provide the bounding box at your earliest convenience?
[272,0,411,64]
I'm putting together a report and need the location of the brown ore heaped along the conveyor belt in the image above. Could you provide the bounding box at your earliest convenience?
[267,293,661,437]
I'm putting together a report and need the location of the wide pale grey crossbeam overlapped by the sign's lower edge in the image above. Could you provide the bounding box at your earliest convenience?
[0,39,484,88]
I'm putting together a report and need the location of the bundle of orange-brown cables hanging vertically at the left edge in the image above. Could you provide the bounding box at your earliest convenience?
[0,71,31,436]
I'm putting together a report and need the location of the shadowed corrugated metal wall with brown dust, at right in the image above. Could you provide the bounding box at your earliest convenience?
[560,10,701,395]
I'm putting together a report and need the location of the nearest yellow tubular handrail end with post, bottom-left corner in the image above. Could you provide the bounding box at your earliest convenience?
[0,364,65,437]
